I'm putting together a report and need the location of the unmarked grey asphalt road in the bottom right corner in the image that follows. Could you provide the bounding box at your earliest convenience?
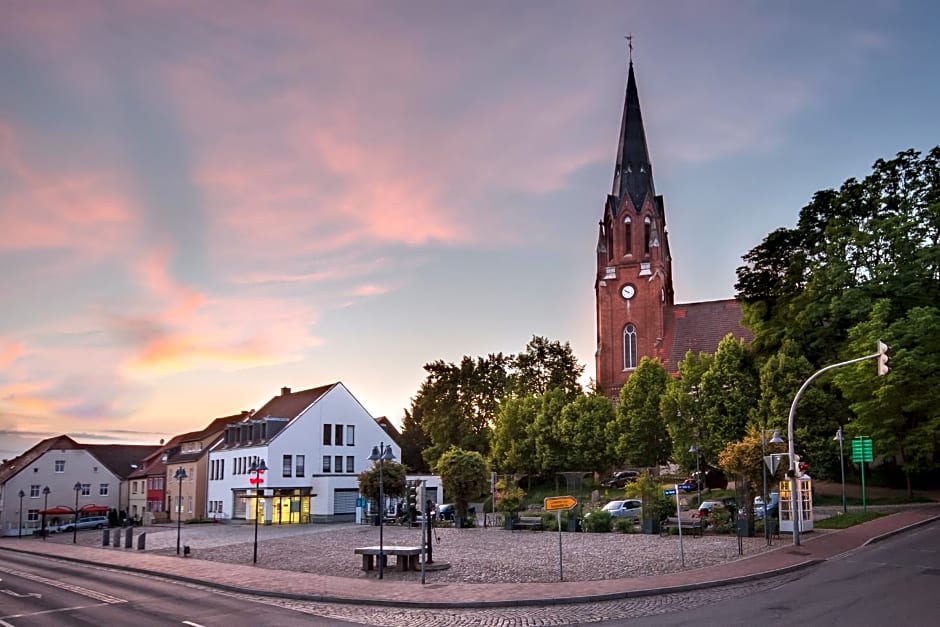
[616,522,940,627]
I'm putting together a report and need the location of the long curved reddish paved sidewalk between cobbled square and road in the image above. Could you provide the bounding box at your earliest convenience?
[0,505,940,608]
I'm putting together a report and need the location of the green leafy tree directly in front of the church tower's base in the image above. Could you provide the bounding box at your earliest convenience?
[607,357,672,467]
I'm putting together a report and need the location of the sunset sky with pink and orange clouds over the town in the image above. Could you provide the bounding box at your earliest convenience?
[0,0,940,459]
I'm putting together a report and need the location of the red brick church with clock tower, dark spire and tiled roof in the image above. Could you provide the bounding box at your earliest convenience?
[594,60,751,398]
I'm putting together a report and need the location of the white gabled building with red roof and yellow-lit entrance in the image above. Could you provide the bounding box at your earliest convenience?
[207,382,401,524]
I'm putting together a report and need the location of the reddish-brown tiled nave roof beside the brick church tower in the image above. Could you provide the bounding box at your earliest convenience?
[665,298,754,373]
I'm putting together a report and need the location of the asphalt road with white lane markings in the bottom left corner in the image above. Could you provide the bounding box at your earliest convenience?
[0,555,342,627]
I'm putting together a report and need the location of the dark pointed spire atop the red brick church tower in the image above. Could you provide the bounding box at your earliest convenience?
[611,61,655,211]
